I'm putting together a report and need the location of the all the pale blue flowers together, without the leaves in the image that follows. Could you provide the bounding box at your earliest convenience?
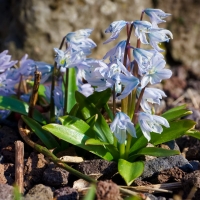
[0,9,173,143]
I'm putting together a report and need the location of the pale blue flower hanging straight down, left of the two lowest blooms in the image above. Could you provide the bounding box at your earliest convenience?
[110,112,137,144]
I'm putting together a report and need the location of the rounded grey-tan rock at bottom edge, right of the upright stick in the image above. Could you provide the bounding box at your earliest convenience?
[24,184,53,200]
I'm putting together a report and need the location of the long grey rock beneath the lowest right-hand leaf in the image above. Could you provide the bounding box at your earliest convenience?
[141,155,193,180]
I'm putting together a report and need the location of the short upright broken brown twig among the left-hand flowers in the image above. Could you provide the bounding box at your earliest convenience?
[28,69,41,118]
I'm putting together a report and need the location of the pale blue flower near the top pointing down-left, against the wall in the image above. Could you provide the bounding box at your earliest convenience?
[104,20,128,44]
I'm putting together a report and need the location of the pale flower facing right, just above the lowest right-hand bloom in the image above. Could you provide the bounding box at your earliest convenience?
[137,87,166,113]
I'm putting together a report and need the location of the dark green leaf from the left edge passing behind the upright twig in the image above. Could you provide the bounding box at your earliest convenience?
[0,96,47,124]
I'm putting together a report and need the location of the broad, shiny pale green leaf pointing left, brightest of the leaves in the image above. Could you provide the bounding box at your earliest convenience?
[43,124,114,160]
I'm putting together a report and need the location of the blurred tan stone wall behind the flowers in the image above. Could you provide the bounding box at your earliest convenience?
[0,0,200,77]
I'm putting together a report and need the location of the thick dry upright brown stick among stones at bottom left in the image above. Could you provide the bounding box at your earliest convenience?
[15,141,24,194]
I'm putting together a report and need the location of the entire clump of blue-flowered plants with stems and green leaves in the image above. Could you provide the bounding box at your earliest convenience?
[0,9,199,185]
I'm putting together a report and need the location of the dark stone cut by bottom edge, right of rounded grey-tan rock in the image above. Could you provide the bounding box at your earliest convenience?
[54,187,79,200]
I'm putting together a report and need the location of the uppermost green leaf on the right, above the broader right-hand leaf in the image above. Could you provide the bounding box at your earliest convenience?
[162,105,192,122]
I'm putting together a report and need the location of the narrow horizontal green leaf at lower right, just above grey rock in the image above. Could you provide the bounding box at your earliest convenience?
[128,147,180,161]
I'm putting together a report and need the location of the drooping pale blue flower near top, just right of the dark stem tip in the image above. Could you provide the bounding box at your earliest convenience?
[133,20,152,44]
